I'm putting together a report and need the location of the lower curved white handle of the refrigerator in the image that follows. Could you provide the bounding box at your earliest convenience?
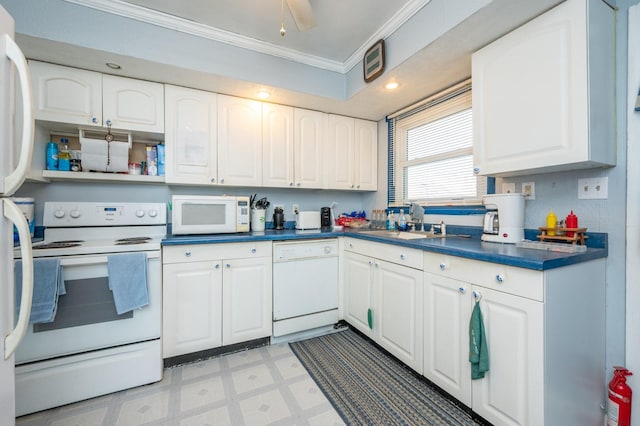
[2,198,33,359]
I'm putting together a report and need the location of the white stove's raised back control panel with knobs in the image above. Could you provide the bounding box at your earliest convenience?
[42,202,167,227]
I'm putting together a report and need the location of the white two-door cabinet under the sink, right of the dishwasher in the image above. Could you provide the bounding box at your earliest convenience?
[343,238,423,373]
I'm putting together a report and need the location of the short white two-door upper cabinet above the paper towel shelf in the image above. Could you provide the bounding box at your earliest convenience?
[29,61,164,133]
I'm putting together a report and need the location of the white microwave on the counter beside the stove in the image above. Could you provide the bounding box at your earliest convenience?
[171,195,250,235]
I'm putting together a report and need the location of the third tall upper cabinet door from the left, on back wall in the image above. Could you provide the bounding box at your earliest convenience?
[262,103,294,188]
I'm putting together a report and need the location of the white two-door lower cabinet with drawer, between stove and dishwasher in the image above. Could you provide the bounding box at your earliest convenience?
[162,242,272,358]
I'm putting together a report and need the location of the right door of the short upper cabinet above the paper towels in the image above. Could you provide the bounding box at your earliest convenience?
[102,74,164,133]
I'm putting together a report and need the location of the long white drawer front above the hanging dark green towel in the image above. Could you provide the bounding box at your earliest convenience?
[424,253,544,301]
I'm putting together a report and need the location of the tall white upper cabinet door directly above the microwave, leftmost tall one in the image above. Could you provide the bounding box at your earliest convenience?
[165,85,218,185]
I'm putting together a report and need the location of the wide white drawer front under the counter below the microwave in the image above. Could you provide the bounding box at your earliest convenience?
[162,241,271,264]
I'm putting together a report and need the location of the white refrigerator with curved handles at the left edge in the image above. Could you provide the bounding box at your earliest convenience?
[0,6,33,426]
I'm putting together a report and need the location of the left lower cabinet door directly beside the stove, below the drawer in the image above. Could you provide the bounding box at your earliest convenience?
[162,261,222,358]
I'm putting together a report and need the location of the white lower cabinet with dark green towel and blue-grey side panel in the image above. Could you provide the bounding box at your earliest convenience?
[424,253,605,425]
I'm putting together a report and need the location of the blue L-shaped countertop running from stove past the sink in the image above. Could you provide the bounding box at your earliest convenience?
[162,226,608,271]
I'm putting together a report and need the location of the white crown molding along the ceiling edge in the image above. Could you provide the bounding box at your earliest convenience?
[64,0,431,74]
